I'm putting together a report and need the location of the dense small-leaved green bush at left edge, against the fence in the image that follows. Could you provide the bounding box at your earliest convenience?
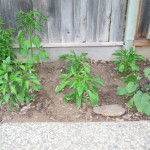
[0,18,16,64]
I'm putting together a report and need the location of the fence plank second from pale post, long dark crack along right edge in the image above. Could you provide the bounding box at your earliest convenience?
[96,0,111,42]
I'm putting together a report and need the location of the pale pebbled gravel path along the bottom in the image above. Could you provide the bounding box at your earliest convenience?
[0,121,150,150]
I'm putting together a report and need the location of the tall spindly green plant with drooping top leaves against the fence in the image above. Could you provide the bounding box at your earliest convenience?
[16,10,48,63]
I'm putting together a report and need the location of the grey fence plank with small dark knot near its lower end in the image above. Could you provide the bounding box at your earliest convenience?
[61,0,74,43]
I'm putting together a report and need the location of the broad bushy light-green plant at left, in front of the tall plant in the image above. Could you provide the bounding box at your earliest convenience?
[0,57,41,108]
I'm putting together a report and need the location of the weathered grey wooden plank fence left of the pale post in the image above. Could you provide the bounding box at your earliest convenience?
[0,0,127,43]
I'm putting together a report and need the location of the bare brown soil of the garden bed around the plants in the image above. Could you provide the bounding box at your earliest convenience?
[0,61,150,122]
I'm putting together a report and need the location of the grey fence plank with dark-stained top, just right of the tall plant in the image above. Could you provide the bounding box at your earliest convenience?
[47,0,61,43]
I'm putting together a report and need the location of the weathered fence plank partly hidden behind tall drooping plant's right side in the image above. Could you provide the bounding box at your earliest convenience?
[32,0,48,43]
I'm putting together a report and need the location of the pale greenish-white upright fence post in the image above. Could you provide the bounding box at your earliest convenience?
[124,0,140,49]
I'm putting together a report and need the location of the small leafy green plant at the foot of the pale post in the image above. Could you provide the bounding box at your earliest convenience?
[113,48,144,75]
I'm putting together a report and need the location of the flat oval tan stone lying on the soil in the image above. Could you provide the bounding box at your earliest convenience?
[93,104,126,117]
